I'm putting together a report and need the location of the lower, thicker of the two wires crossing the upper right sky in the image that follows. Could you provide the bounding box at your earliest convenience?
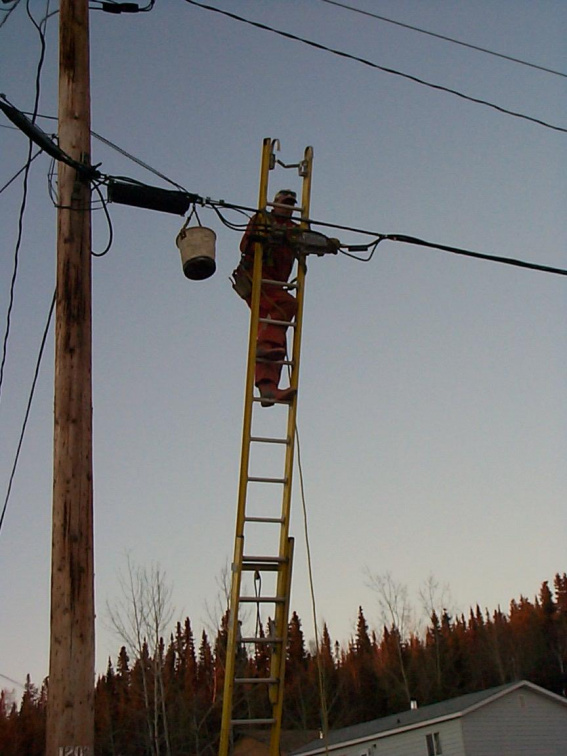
[185,0,567,134]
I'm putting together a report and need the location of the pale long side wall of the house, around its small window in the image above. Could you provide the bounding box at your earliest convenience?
[330,720,466,756]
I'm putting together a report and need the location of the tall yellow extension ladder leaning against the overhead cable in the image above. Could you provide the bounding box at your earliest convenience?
[219,138,313,756]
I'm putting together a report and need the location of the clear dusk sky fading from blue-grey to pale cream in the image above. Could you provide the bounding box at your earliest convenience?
[0,0,567,696]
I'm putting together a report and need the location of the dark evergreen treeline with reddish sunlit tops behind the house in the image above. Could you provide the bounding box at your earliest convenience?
[0,573,567,756]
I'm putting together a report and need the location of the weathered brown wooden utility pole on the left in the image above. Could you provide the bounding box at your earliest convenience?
[46,0,94,756]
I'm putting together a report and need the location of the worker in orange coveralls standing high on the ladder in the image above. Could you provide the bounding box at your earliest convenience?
[235,189,297,407]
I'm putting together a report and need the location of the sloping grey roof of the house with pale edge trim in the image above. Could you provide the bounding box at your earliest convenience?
[293,680,567,756]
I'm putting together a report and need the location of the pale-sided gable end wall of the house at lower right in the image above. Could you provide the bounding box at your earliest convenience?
[462,688,567,756]
